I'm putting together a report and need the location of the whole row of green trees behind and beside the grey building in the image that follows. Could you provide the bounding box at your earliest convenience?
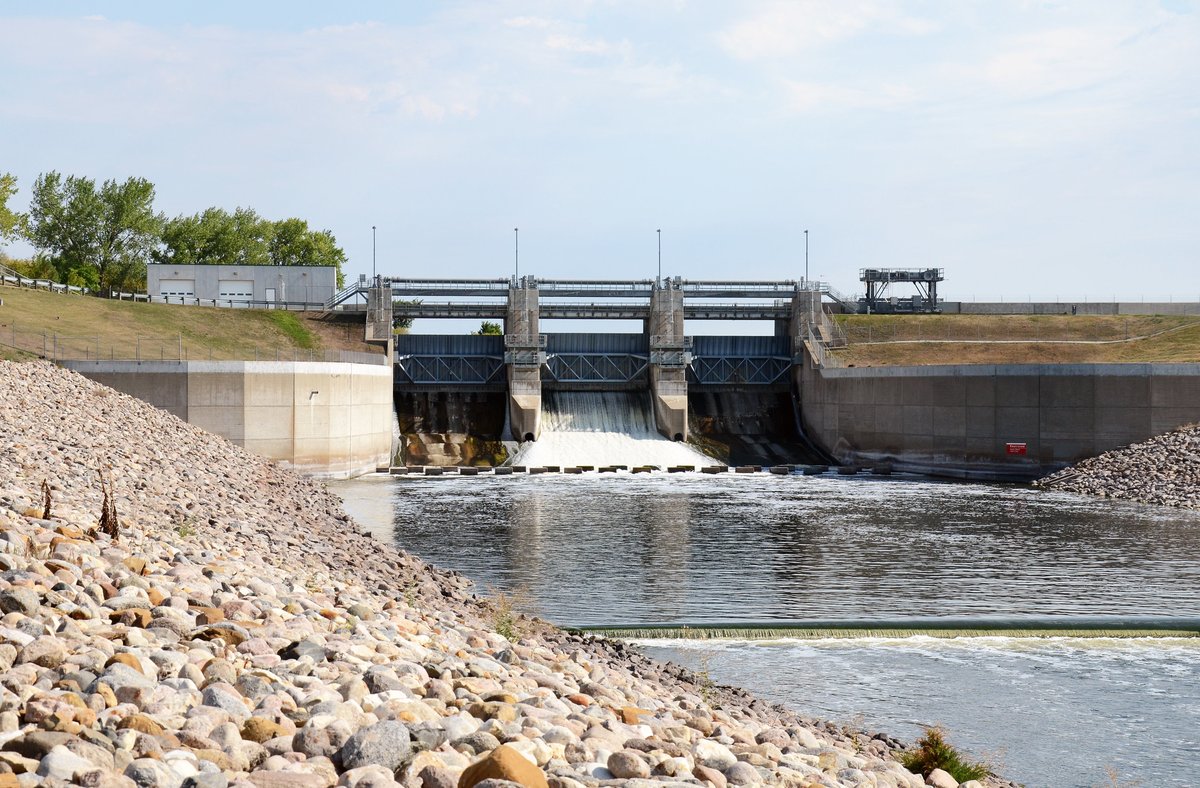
[0,172,346,290]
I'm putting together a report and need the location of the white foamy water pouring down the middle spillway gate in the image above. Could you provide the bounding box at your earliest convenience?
[512,391,716,468]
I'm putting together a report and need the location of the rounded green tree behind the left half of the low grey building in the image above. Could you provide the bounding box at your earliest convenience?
[155,207,275,265]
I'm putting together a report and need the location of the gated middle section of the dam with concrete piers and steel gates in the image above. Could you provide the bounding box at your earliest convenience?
[362,277,822,464]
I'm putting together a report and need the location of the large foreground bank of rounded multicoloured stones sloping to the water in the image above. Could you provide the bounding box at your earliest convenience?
[0,362,993,788]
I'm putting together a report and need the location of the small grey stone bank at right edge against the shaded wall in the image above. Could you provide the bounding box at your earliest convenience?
[1033,425,1200,509]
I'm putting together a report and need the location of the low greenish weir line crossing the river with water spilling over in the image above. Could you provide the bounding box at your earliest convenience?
[563,615,1200,640]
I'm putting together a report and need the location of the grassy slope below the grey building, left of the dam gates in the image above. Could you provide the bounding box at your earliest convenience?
[0,287,379,360]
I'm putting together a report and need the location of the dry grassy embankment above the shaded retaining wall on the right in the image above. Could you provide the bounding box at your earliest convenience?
[836,314,1200,367]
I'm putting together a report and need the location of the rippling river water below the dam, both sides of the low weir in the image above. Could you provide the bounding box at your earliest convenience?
[331,474,1200,786]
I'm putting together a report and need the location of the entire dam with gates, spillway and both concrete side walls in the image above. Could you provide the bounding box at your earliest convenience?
[54,276,1200,481]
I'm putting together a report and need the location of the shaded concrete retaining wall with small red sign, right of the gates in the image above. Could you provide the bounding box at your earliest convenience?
[798,360,1200,480]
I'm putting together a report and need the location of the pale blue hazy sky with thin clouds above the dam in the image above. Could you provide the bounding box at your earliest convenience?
[0,0,1200,300]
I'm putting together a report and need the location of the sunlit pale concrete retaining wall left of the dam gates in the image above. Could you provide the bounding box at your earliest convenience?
[64,361,392,479]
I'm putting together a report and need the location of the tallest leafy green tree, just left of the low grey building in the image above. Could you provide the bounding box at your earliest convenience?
[26,172,162,289]
